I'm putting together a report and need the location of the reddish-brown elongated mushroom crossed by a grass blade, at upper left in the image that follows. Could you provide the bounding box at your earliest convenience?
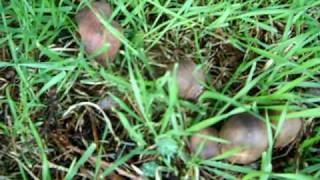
[76,1,122,66]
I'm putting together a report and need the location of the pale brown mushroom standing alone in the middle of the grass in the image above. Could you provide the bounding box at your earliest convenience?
[172,60,205,100]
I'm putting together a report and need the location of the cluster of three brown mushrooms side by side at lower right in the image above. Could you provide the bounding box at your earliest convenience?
[191,112,303,164]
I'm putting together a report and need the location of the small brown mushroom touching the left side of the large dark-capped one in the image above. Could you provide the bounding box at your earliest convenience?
[190,128,220,159]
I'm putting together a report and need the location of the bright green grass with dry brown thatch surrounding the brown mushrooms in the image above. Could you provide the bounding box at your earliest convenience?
[0,0,320,179]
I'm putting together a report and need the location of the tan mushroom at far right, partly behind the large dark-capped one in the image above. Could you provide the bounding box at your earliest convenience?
[271,112,303,148]
